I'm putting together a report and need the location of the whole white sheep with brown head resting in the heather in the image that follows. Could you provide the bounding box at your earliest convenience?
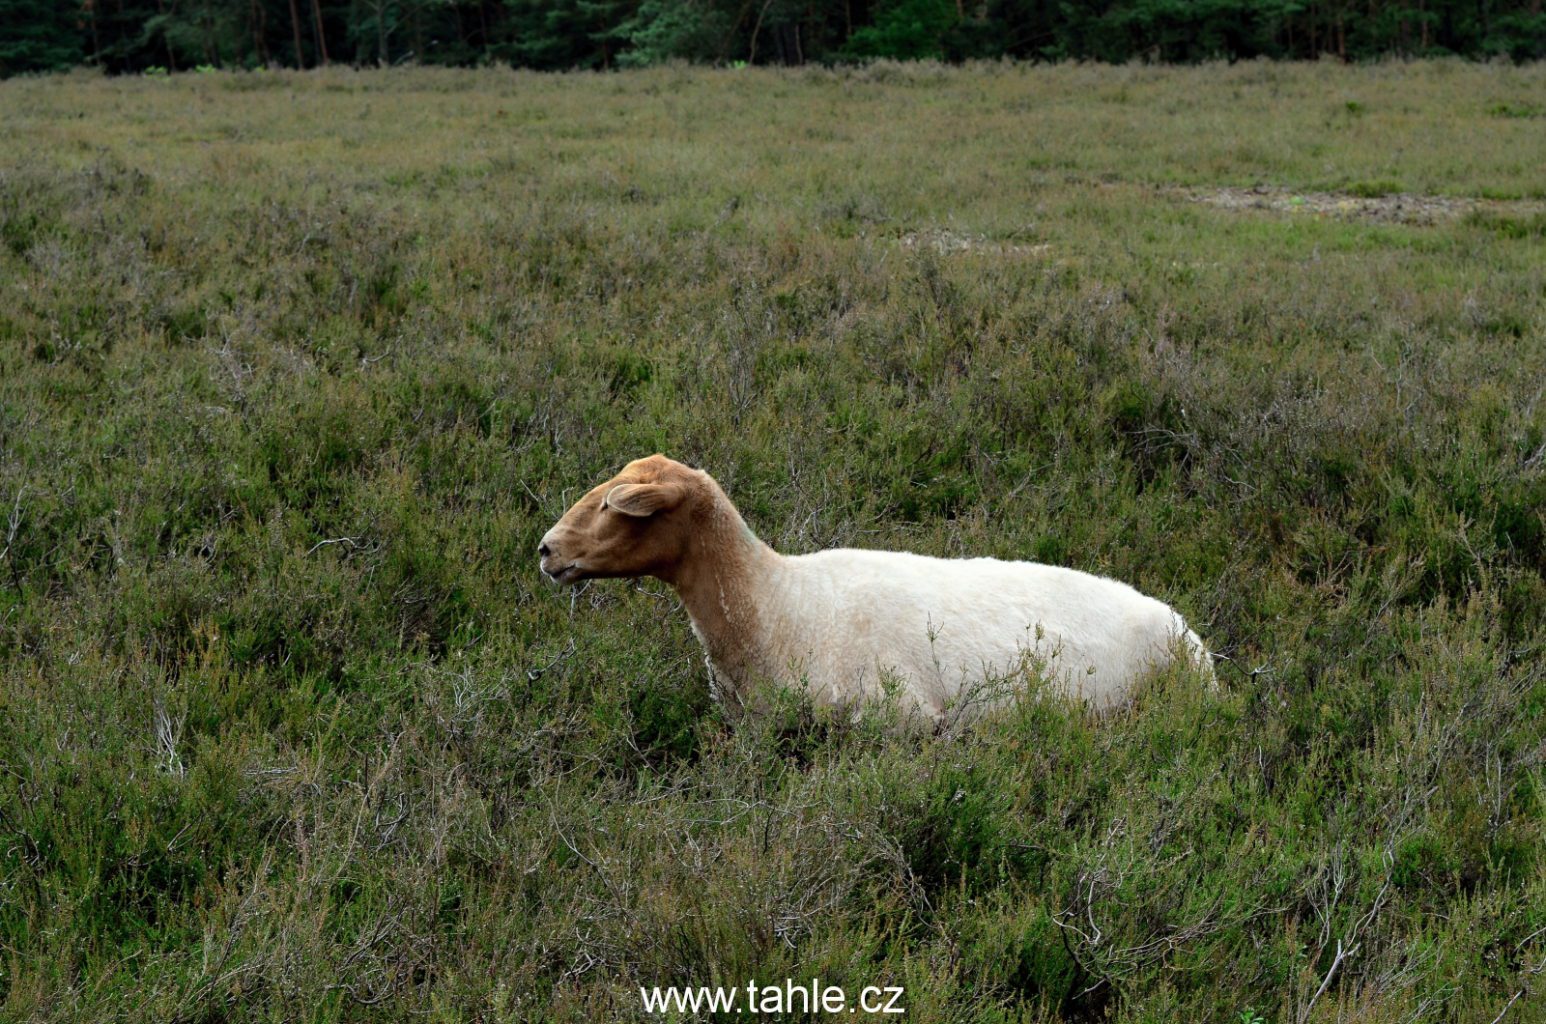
[536,455,1212,725]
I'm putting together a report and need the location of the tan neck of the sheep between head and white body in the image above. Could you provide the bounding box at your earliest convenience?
[671,501,778,685]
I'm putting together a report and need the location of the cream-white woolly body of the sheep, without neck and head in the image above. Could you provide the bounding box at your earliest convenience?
[767,549,1200,713]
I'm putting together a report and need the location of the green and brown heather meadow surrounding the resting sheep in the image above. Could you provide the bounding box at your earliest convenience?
[0,62,1546,1024]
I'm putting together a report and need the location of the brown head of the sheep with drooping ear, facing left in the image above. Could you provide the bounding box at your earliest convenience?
[536,455,708,583]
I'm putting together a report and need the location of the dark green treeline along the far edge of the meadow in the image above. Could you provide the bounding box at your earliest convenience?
[0,0,1546,74]
